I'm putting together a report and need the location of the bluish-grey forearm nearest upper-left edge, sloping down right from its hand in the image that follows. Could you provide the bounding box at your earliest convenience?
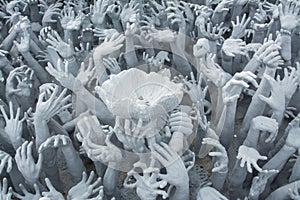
[21,52,50,83]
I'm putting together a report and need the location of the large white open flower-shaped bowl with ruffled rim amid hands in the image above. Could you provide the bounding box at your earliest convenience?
[95,68,183,122]
